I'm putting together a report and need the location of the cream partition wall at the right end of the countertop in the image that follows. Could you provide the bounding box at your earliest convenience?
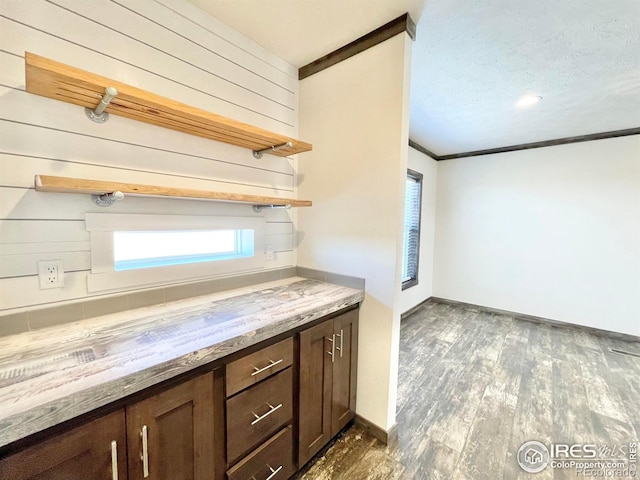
[298,33,411,430]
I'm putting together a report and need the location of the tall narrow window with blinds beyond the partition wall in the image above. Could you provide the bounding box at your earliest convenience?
[402,170,422,290]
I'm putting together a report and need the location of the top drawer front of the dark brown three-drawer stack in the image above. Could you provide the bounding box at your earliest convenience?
[226,338,293,397]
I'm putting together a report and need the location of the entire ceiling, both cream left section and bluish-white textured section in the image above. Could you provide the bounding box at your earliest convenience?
[185,0,640,155]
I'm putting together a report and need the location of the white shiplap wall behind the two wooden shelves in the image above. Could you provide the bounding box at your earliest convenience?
[0,0,298,315]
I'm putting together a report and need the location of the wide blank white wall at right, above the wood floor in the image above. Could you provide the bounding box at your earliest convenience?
[433,135,640,335]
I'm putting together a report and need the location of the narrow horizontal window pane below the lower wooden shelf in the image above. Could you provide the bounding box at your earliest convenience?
[113,229,254,271]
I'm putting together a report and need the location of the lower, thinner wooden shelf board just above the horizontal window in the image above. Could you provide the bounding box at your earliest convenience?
[35,175,311,207]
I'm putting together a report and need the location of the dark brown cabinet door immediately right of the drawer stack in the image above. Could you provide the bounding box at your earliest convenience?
[298,320,335,466]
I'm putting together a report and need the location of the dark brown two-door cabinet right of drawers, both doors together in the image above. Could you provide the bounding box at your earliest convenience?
[298,310,358,467]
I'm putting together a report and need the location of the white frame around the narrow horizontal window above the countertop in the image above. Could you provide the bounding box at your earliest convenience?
[85,213,266,293]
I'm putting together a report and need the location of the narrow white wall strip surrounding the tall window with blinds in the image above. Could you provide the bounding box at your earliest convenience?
[400,148,438,313]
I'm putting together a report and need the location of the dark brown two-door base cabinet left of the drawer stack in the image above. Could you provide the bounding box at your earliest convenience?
[0,369,224,480]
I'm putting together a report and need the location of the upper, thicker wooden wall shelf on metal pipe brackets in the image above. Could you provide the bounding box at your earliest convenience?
[25,52,312,157]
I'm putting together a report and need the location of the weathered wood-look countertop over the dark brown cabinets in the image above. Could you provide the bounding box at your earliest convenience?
[0,277,364,447]
